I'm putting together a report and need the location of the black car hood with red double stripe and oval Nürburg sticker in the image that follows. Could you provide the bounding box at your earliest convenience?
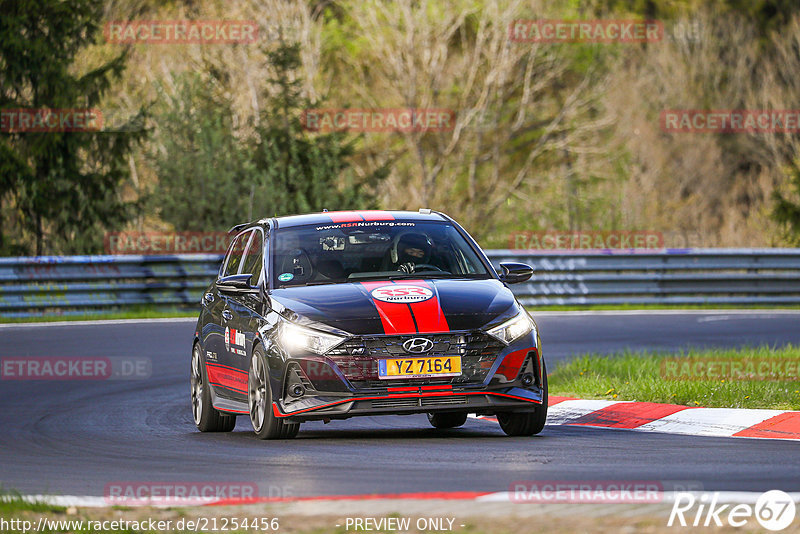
[271,279,516,335]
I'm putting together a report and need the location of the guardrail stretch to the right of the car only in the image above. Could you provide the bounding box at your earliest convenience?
[489,249,800,305]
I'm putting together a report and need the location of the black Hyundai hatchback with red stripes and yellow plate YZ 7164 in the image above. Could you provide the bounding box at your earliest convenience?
[191,210,547,439]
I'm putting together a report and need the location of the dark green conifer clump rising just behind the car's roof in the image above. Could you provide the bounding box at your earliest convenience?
[154,44,388,231]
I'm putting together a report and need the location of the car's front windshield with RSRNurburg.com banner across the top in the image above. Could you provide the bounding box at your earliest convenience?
[272,221,490,288]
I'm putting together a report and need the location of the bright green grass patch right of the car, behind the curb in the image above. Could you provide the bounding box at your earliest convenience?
[548,346,800,410]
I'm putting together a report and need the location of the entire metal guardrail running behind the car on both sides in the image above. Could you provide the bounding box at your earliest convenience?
[0,249,800,317]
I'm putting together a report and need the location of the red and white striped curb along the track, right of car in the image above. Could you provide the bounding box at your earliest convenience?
[476,397,800,440]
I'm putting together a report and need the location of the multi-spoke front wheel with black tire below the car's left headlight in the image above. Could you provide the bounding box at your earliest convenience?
[247,345,300,439]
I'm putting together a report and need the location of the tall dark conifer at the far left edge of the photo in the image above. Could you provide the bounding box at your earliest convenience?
[0,0,145,255]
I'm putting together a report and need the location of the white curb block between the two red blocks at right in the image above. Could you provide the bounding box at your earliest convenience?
[634,408,785,436]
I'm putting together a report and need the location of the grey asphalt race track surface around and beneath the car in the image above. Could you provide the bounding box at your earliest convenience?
[0,312,800,497]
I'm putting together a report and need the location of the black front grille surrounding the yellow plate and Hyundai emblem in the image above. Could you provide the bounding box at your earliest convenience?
[327,332,503,388]
